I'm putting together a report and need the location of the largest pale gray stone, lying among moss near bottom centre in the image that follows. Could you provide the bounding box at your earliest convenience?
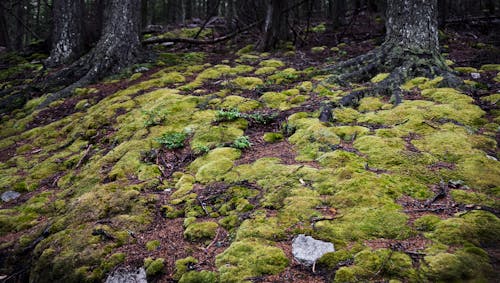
[292,234,335,266]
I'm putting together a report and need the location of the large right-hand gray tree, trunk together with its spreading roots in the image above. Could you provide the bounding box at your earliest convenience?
[325,0,462,105]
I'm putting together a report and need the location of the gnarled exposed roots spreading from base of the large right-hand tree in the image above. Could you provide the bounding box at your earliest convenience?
[321,43,463,106]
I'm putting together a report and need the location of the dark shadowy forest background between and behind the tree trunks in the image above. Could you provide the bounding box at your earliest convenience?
[0,0,500,52]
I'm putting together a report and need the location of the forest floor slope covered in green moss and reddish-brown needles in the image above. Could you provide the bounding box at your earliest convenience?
[0,16,500,282]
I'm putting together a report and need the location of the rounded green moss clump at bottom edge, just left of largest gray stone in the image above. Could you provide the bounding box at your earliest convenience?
[215,240,289,282]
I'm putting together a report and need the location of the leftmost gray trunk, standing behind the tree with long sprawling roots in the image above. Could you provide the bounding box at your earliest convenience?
[45,0,84,67]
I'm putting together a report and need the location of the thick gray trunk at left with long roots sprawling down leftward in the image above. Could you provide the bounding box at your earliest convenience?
[40,0,142,107]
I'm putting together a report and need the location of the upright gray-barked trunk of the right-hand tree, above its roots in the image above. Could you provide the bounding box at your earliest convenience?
[386,0,439,54]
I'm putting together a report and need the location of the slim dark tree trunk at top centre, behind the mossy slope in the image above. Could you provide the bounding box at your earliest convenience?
[258,0,289,51]
